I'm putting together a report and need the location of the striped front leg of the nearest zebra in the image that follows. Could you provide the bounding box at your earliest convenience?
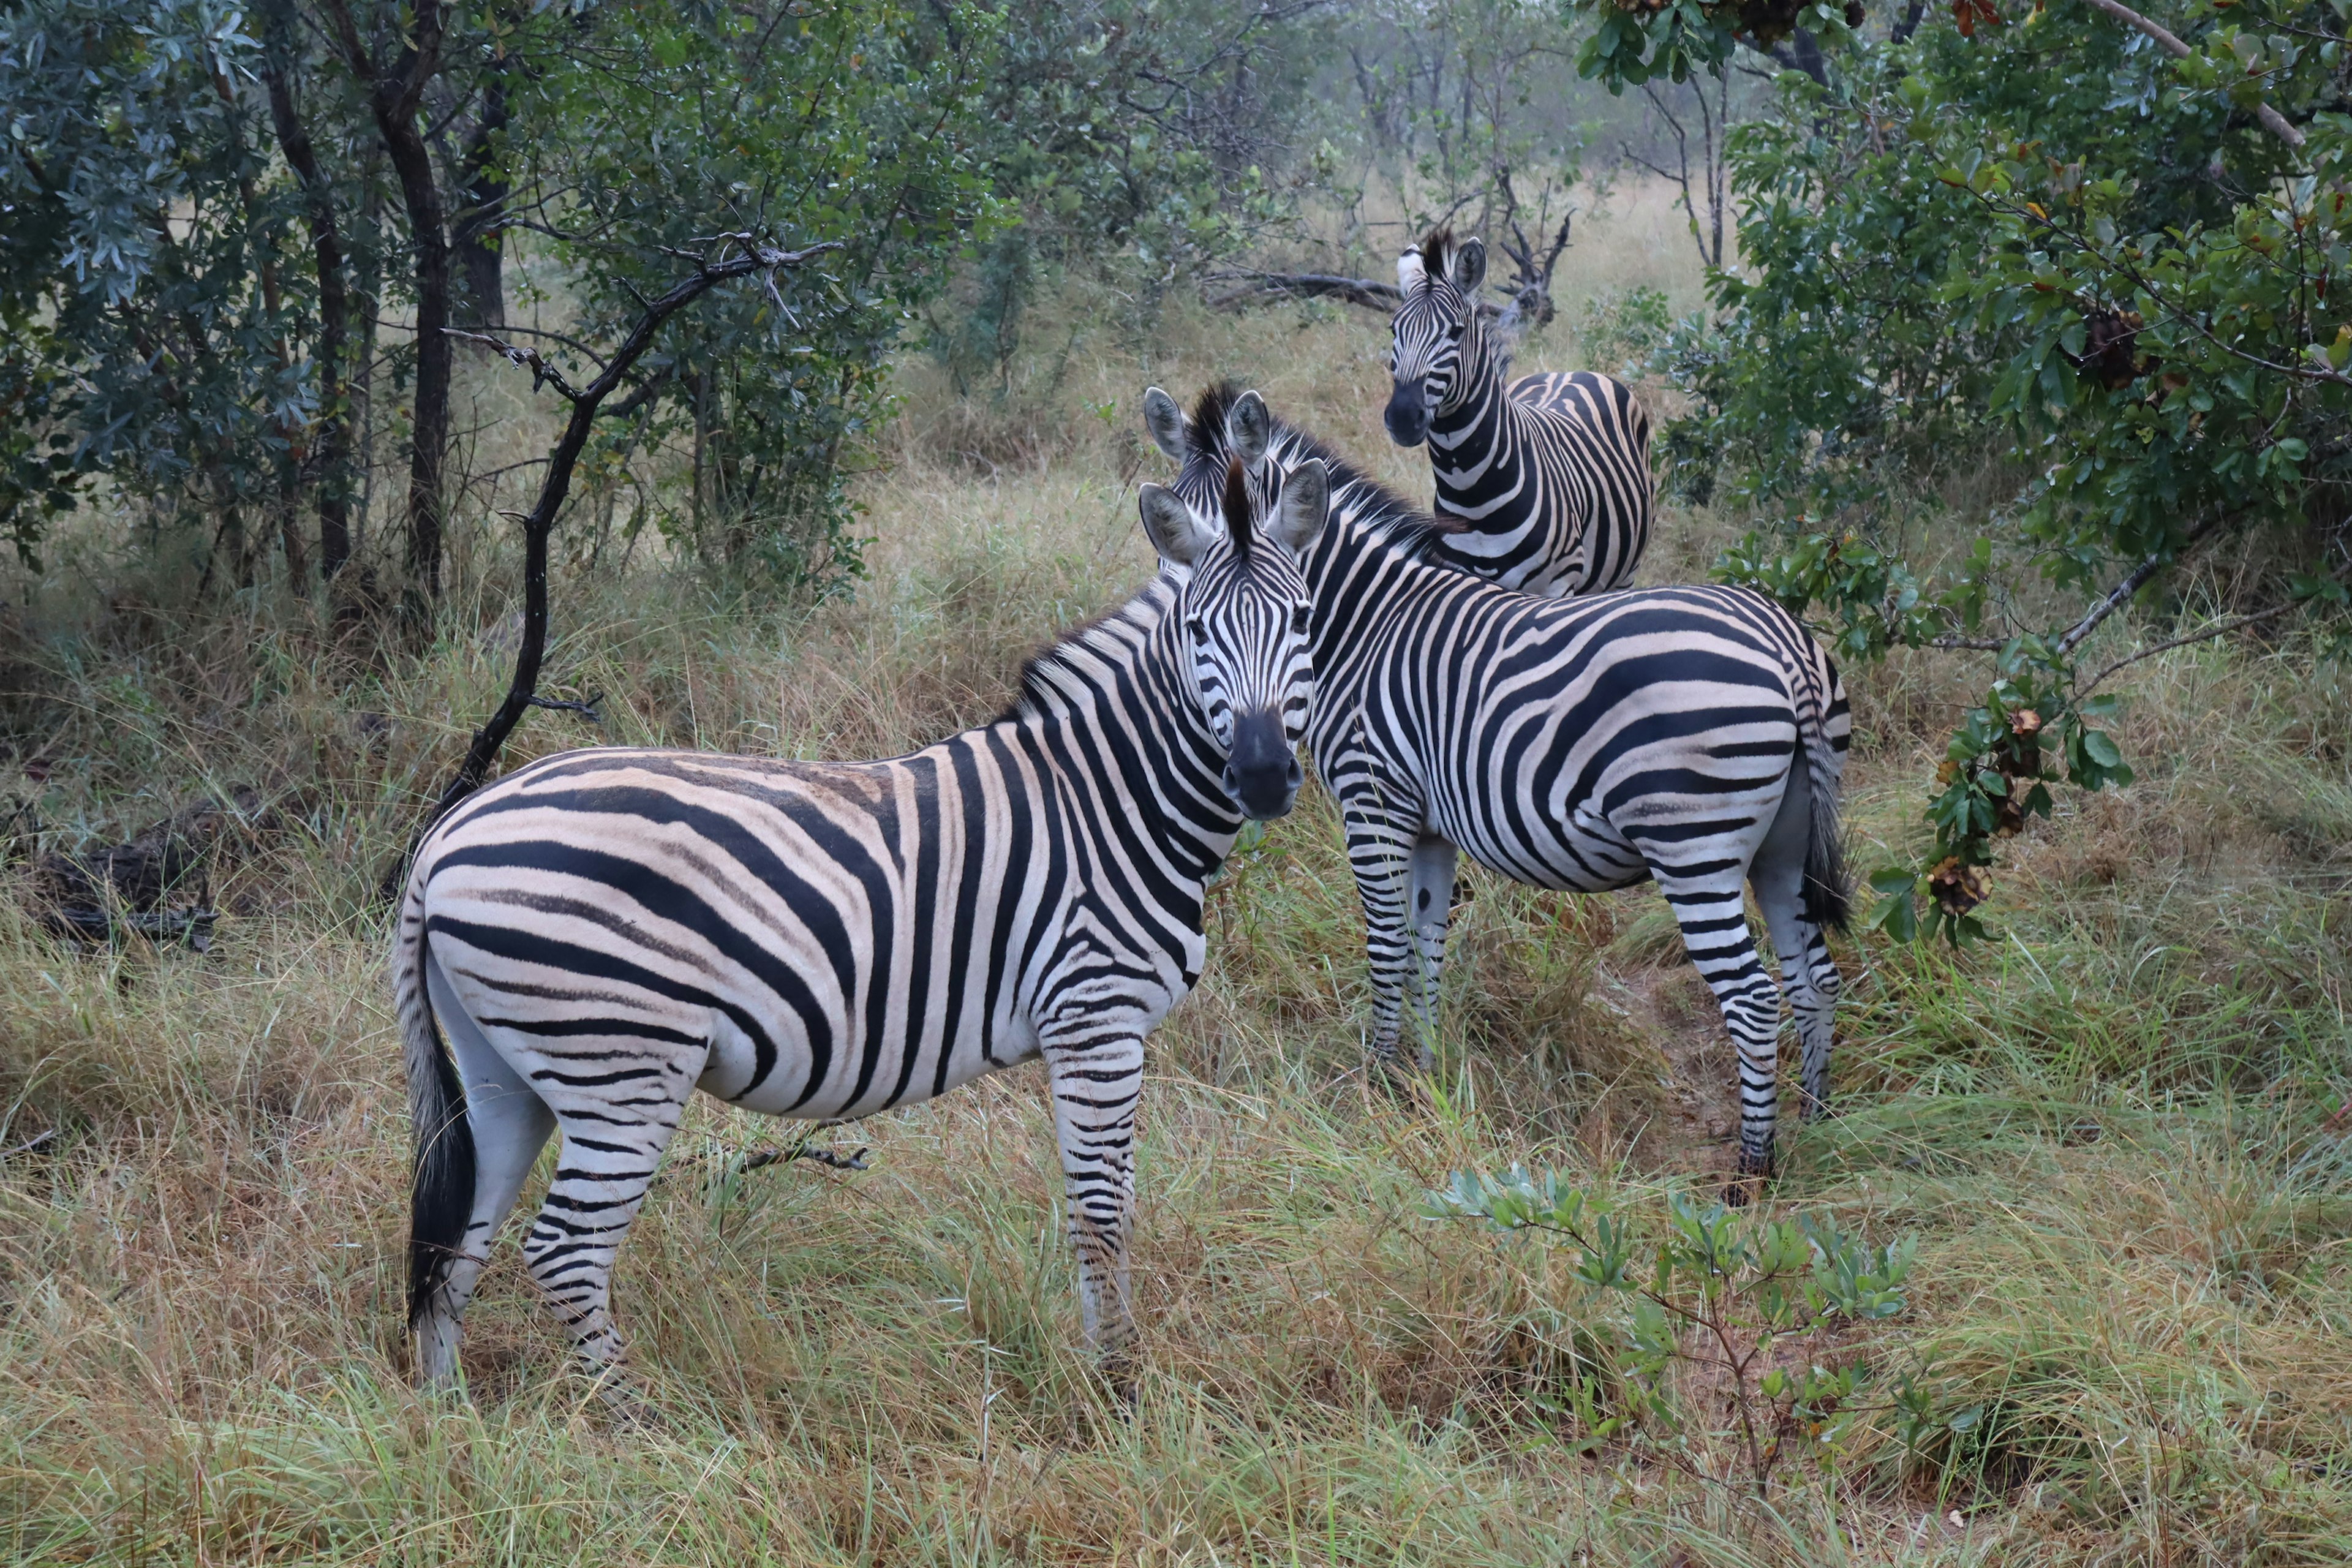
[1044,1035,1143,1403]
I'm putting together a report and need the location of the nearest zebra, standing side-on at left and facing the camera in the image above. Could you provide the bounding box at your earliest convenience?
[393,451,1327,1408]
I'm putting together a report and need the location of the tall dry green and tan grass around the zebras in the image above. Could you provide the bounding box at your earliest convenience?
[0,200,2352,1568]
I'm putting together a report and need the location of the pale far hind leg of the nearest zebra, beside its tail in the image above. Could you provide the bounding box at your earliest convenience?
[417,957,555,1387]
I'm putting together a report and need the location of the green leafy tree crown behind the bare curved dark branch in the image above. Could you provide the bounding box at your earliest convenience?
[522,0,992,590]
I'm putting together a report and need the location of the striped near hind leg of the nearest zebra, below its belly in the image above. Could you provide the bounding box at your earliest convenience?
[522,1046,701,1406]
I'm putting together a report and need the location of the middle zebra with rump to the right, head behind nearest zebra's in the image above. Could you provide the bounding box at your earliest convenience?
[1145,385,1851,1175]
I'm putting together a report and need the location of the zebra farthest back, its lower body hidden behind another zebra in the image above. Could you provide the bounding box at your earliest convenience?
[1383,228,1656,597]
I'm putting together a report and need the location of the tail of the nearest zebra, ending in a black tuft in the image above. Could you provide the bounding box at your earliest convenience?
[393,865,473,1329]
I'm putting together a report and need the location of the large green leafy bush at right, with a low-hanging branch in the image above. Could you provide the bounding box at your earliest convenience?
[1608,5,2352,940]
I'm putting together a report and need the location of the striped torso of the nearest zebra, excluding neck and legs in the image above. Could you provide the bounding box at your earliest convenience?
[426,748,1068,1119]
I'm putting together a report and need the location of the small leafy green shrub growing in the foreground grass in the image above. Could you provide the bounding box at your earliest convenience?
[1428,1166,1924,1495]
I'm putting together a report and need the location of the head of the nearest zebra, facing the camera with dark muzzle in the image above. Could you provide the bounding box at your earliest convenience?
[1139,451,1331,823]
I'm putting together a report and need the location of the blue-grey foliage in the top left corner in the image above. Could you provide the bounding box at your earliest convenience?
[0,0,311,564]
